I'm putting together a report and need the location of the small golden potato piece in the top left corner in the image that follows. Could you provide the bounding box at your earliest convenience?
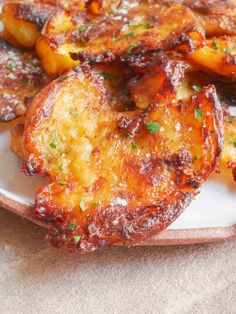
[0,1,52,48]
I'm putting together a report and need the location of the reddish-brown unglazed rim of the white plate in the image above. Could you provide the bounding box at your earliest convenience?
[0,192,236,246]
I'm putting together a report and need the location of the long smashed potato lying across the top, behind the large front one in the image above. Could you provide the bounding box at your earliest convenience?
[36,2,202,74]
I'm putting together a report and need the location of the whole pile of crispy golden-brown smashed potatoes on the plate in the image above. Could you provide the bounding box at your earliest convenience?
[0,0,236,253]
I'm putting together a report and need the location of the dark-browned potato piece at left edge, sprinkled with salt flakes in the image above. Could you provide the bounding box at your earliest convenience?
[0,40,49,122]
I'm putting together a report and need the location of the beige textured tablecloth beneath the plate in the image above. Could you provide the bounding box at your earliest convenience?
[0,209,236,314]
